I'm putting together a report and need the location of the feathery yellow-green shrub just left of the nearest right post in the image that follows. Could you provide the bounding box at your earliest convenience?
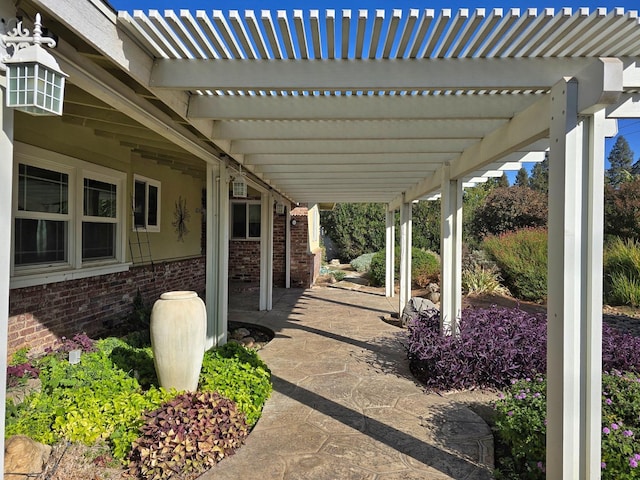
[482,228,547,301]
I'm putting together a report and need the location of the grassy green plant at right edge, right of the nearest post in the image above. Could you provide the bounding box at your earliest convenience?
[603,237,640,307]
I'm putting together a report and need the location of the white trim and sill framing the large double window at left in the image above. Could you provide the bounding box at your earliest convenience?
[10,142,130,288]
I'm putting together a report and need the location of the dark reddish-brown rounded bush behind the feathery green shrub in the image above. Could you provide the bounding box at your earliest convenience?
[470,187,547,238]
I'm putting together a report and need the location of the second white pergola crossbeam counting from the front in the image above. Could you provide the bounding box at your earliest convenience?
[188,94,537,120]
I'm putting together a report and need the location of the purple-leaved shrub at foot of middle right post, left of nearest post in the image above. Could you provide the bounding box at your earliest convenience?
[407,306,547,390]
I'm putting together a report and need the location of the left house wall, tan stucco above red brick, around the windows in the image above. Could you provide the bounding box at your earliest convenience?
[8,112,205,355]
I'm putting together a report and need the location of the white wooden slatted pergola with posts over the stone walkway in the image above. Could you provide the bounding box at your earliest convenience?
[0,0,640,479]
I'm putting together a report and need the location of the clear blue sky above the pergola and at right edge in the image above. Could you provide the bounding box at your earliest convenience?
[108,0,640,180]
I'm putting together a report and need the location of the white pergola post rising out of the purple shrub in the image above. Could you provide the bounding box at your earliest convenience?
[440,165,462,335]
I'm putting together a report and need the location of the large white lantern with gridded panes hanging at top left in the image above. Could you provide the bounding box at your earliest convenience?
[0,13,68,115]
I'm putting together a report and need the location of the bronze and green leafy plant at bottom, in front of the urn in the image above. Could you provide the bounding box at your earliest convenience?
[129,392,249,479]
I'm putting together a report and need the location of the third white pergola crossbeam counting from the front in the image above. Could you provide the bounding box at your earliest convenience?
[213,118,504,141]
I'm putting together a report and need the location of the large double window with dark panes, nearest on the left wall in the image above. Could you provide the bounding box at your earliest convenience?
[12,144,126,278]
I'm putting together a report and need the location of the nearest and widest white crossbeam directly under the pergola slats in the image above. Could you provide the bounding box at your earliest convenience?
[149,57,592,91]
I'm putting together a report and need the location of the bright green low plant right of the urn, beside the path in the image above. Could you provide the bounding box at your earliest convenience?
[199,343,272,425]
